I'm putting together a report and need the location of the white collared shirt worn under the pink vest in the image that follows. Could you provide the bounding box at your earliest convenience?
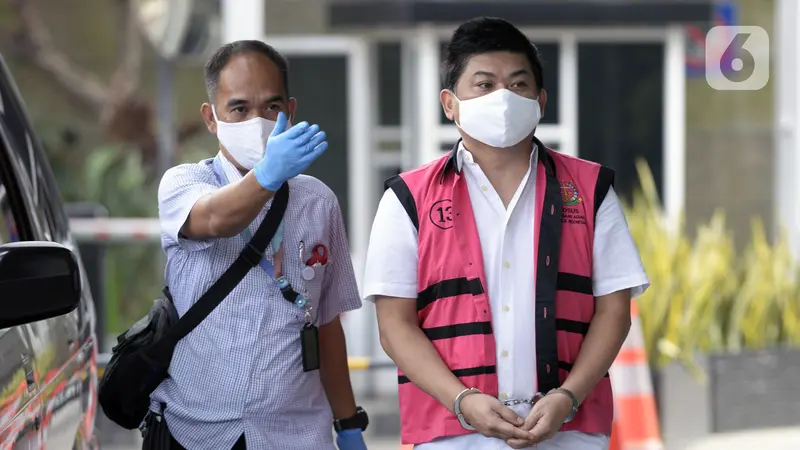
[363,144,649,450]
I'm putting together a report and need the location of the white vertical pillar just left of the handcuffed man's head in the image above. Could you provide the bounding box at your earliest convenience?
[413,26,442,165]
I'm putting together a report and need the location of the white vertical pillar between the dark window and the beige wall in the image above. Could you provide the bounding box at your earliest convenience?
[663,25,686,230]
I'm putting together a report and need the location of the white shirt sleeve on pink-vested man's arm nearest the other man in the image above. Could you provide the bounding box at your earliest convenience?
[363,189,418,301]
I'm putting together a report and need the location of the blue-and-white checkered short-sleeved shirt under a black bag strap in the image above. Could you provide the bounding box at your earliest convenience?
[151,154,361,450]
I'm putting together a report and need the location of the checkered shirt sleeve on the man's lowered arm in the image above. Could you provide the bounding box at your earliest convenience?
[318,197,361,325]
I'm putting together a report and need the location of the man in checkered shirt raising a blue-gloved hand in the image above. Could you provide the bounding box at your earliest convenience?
[145,41,367,450]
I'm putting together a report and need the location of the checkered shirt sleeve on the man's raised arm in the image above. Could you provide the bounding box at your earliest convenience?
[158,164,218,252]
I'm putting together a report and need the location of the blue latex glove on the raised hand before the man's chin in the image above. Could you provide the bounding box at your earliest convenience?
[253,112,328,191]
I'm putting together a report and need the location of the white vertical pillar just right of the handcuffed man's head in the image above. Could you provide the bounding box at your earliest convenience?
[560,32,578,156]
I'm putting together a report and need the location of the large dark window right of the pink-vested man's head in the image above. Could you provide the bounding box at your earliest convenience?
[578,43,664,201]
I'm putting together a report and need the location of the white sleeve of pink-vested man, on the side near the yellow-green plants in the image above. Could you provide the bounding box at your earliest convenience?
[592,187,650,298]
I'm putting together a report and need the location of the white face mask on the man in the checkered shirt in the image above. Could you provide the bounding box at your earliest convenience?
[211,106,291,170]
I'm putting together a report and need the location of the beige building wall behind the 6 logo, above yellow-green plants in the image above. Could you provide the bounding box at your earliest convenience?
[686,0,775,245]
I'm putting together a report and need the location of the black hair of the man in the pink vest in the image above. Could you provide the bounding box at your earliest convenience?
[442,17,544,91]
